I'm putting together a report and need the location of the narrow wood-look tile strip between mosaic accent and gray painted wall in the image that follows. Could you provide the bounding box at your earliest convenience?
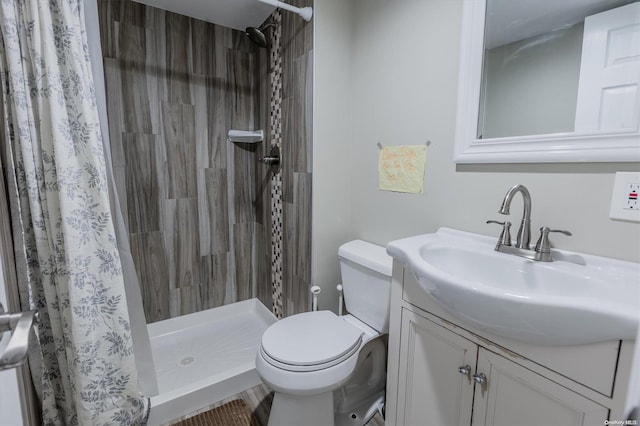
[280,0,312,316]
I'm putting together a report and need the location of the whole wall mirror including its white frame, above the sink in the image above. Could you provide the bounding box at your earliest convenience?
[454,0,640,163]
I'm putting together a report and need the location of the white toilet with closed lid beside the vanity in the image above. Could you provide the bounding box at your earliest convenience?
[256,240,392,426]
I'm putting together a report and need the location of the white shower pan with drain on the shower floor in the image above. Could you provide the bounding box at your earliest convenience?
[148,299,277,426]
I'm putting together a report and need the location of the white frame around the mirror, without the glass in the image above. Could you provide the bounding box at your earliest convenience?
[453,0,640,164]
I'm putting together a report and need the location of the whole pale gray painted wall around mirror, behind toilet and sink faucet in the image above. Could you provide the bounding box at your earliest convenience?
[313,0,640,307]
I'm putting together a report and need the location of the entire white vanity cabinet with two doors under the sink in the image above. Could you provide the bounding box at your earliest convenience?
[386,263,632,426]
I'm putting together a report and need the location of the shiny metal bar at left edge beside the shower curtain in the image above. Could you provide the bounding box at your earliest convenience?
[0,305,37,371]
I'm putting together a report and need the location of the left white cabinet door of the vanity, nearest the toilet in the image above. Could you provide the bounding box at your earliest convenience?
[395,309,477,426]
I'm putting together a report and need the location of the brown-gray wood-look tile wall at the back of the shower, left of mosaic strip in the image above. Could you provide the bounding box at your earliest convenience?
[98,0,272,322]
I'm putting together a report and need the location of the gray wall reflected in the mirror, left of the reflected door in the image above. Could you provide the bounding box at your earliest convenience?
[479,23,584,138]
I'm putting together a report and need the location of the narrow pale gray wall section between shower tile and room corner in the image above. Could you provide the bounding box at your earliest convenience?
[312,0,355,311]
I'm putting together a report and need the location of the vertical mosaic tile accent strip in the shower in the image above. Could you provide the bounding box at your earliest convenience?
[269,10,284,318]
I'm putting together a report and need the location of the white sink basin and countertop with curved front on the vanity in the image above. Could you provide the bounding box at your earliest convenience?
[387,228,640,346]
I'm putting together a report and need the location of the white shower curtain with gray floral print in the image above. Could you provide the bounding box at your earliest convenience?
[0,0,148,425]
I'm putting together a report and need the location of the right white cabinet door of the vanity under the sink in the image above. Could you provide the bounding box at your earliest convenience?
[472,348,608,426]
